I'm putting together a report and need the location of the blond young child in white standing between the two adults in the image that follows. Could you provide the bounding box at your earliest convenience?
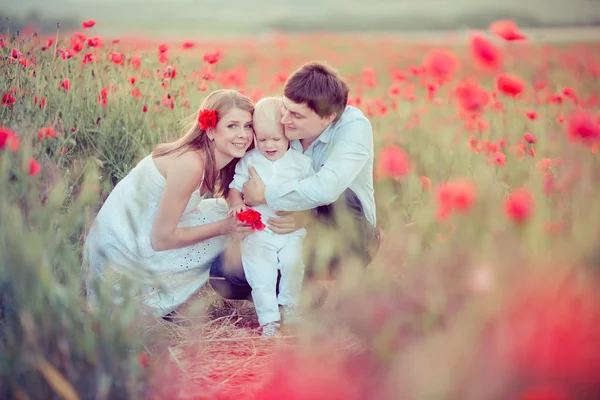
[228,97,314,338]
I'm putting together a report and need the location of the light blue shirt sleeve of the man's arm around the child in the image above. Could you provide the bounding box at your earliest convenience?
[265,120,373,211]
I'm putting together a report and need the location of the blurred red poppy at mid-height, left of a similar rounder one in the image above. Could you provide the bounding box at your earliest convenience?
[436,179,477,221]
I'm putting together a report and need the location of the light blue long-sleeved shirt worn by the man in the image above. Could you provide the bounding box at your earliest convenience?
[265,106,376,226]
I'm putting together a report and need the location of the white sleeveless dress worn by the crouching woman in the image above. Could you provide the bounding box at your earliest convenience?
[84,155,227,316]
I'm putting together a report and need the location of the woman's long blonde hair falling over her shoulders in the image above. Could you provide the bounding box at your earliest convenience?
[152,89,254,197]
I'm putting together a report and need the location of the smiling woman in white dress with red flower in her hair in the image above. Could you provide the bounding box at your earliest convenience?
[84,90,254,317]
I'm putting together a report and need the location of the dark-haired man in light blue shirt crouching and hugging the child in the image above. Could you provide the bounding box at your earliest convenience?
[211,62,379,299]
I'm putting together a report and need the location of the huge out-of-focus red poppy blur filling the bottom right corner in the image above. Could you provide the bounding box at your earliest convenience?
[478,274,600,400]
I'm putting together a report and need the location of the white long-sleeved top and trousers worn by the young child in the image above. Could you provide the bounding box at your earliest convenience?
[229,149,314,325]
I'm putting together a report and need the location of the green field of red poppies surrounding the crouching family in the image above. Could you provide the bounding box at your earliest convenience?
[0,20,600,400]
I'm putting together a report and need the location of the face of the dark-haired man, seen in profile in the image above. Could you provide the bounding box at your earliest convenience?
[281,97,336,140]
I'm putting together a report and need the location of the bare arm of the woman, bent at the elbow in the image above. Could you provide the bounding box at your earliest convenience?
[151,152,230,251]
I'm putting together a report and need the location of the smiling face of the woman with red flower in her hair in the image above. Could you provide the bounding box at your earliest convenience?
[207,108,254,158]
